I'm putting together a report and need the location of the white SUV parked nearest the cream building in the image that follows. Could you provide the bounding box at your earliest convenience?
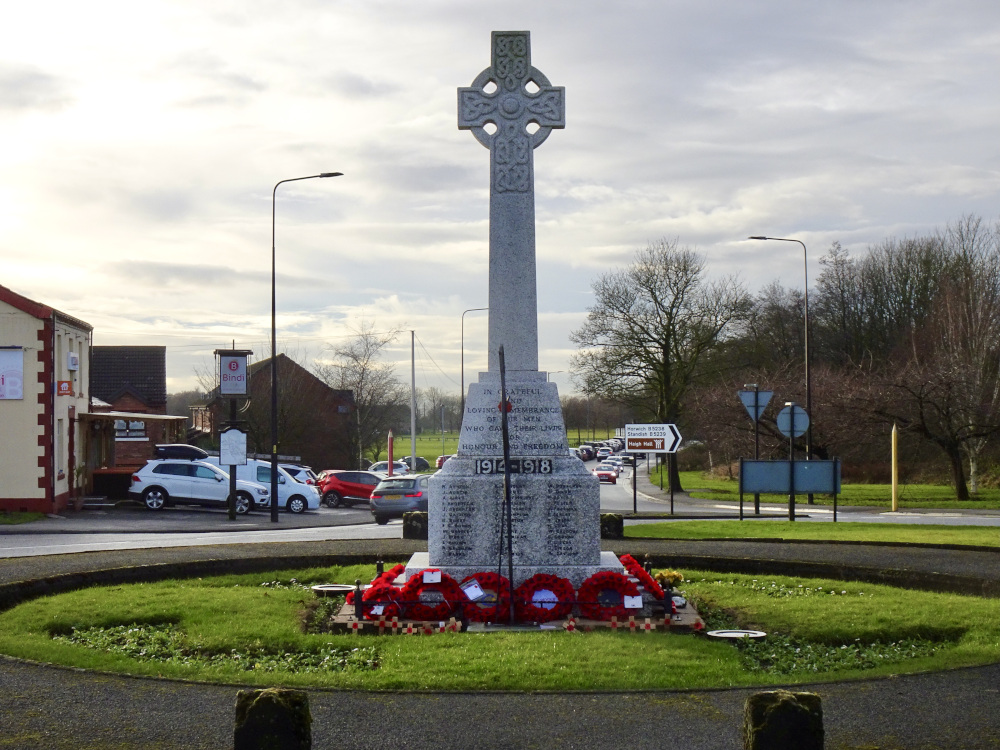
[128,458,269,514]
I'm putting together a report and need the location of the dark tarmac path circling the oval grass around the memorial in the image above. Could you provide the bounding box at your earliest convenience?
[0,539,1000,750]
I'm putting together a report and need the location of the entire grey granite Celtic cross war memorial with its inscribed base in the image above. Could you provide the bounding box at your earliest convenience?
[406,31,622,587]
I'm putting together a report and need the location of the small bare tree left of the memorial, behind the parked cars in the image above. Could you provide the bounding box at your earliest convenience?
[314,321,409,464]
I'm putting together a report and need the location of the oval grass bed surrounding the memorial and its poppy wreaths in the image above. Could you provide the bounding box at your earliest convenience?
[0,565,1000,691]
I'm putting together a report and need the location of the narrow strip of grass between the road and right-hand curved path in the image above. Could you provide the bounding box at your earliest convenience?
[625,524,1000,547]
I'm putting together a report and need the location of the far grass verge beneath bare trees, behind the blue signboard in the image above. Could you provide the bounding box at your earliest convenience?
[639,470,1000,510]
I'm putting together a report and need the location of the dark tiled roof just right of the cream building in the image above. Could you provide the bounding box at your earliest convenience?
[90,346,167,406]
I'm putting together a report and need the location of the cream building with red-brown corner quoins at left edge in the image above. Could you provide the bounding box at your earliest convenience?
[0,286,93,513]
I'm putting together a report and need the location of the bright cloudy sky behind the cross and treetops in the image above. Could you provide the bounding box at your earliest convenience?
[0,0,1000,394]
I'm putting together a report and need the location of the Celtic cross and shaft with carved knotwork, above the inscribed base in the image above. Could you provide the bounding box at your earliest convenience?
[458,31,566,371]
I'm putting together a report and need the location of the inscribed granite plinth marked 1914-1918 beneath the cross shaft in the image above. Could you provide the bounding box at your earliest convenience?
[406,372,622,587]
